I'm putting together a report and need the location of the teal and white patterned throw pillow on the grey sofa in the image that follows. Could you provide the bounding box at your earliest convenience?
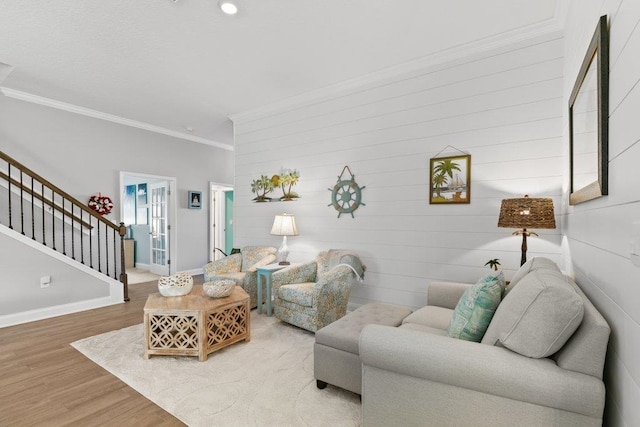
[448,271,504,342]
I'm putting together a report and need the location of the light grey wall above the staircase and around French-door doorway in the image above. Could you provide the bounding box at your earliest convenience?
[0,95,233,271]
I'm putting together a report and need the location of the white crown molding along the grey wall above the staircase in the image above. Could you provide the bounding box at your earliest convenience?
[0,86,234,151]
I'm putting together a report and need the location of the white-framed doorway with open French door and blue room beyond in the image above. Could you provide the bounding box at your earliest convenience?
[120,172,178,275]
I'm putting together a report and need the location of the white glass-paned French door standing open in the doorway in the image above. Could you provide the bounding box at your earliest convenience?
[149,181,171,276]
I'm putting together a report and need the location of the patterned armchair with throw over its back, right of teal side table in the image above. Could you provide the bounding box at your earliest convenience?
[272,250,365,332]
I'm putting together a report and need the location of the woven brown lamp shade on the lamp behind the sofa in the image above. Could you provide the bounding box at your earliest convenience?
[498,196,556,228]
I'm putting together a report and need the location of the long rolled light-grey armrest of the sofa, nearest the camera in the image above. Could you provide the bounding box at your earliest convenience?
[360,325,605,418]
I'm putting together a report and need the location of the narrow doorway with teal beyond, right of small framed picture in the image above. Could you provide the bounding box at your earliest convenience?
[209,182,233,261]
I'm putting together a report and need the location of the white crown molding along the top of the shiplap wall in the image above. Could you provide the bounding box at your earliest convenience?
[229,17,562,124]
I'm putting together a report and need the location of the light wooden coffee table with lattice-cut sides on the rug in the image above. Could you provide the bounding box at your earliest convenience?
[144,285,251,361]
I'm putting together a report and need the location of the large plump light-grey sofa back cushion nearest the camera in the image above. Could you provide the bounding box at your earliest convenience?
[482,269,584,358]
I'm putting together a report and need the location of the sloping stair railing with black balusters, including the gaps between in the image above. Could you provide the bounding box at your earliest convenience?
[0,151,129,301]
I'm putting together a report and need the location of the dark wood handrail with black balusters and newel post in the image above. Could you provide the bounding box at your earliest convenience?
[0,151,129,301]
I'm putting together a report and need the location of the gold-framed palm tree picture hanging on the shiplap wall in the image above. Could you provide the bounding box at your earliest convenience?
[429,154,471,204]
